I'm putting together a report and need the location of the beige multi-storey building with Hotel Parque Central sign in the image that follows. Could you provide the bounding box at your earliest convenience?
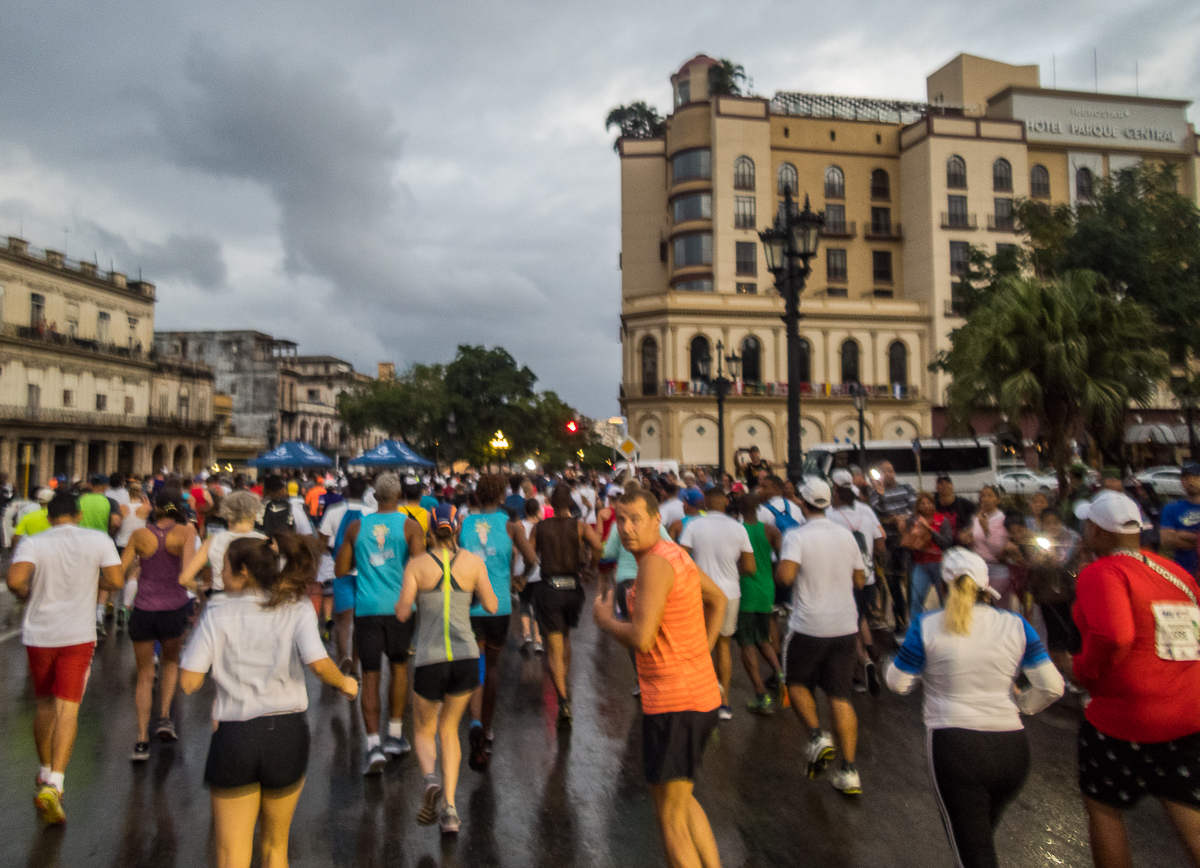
[618,54,1200,468]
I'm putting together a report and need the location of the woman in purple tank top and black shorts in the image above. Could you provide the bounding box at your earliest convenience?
[121,489,196,762]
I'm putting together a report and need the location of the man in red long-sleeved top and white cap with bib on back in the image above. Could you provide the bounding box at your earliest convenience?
[1073,492,1200,868]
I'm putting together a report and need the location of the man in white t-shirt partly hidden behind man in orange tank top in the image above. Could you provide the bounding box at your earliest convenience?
[679,489,756,720]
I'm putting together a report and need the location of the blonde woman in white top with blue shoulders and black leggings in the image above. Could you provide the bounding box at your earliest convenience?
[886,549,1063,868]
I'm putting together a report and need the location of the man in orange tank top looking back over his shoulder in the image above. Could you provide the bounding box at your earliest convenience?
[592,491,726,868]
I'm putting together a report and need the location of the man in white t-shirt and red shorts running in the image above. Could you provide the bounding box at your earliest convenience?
[8,491,125,824]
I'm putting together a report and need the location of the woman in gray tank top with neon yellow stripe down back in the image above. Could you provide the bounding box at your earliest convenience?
[396,503,500,834]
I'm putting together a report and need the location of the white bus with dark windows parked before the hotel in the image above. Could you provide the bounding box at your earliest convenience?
[804,437,996,495]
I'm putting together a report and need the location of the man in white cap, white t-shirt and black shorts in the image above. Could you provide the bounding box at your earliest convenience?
[776,479,866,795]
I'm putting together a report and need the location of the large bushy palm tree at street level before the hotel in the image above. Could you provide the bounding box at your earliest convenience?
[931,271,1168,491]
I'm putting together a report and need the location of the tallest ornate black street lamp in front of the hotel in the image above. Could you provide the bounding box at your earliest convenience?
[758,187,824,485]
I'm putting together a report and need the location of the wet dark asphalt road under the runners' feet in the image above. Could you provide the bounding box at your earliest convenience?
[0,576,1186,868]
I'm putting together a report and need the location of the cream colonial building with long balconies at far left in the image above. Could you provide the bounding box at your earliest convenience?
[0,238,212,490]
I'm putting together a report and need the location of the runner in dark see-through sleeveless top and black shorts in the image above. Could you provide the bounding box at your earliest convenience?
[530,483,604,726]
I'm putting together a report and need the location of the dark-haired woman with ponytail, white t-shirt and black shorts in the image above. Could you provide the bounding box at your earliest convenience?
[180,533,359,868]
